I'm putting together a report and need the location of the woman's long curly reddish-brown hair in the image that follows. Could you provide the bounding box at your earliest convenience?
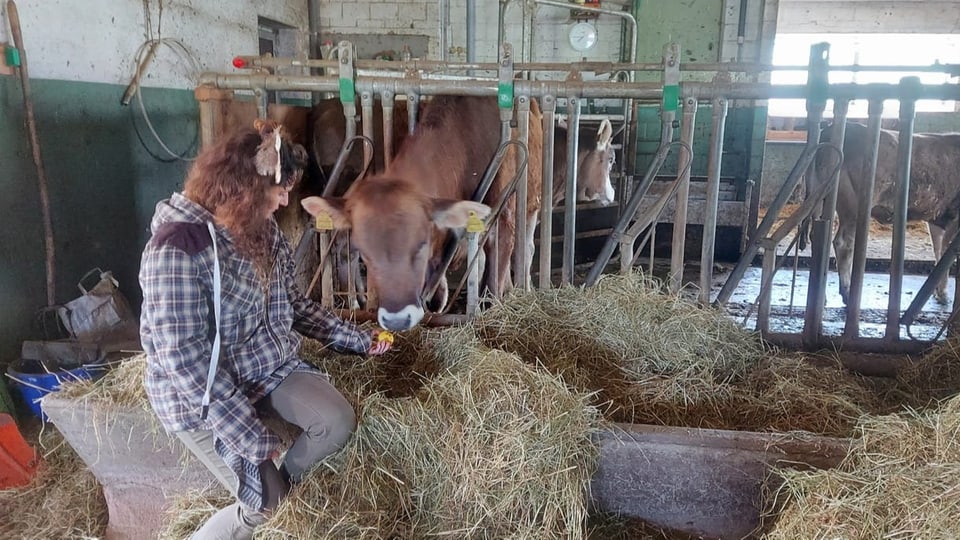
[183,123,307,270]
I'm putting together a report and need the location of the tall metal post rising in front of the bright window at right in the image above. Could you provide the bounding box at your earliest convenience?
[804,43,833,344]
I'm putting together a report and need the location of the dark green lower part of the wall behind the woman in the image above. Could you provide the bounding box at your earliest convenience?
[0,77,198,366]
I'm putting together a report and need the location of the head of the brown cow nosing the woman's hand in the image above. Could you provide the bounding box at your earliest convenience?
[302,178,490,331]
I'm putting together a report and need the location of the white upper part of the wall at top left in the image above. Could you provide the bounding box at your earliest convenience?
[0,0,308,89]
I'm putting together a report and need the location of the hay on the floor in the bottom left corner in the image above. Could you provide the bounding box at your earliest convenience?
[0,426,107,540]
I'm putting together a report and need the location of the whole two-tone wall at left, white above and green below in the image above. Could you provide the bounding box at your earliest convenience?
[0,0,307,367]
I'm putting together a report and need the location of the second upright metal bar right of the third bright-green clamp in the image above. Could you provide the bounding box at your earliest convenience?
[700,97,727,305]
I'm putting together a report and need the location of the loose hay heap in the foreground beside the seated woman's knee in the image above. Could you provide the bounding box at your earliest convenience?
[258,329,597,539]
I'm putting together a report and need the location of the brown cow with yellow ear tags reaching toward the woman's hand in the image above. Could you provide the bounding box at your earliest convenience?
[302,96,543,330]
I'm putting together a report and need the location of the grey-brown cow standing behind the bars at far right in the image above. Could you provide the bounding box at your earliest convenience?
[808,122,960,303]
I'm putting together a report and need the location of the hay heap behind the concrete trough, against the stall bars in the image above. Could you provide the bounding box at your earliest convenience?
[474,273,896,436]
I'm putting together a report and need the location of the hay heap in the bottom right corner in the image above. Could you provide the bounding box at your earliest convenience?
[766,397,960,539]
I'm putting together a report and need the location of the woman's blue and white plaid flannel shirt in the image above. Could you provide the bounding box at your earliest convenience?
[140,193,372,509]
